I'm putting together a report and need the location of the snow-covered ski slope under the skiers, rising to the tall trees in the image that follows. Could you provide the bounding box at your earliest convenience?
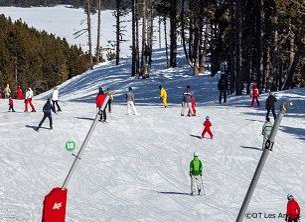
[0,47,305,222]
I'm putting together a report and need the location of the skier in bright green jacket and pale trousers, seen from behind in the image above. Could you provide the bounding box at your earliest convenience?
[190,152,202,195]
